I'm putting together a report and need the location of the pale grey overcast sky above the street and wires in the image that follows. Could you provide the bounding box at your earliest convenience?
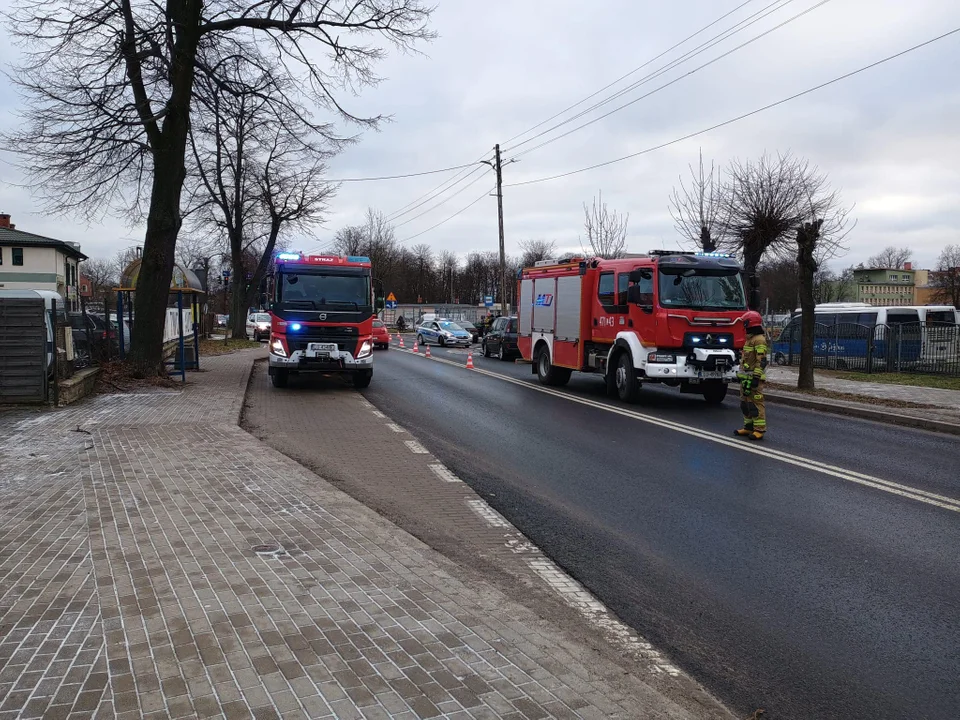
[0,0,960,266]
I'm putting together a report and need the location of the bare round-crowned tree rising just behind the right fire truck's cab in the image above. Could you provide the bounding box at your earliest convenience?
[720,153,809,310]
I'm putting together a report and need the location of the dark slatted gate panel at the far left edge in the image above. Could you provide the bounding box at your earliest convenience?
[0,297,47,404]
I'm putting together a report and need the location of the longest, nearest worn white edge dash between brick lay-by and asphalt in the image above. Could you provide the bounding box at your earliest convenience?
[527,557,681,677]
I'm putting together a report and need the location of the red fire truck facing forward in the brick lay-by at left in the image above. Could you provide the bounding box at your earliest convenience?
[269,252,379,388]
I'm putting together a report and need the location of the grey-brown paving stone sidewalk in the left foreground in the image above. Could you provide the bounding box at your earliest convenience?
[0,351,720,720]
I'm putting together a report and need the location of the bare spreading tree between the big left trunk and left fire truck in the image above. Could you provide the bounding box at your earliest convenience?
[190,59,342,338]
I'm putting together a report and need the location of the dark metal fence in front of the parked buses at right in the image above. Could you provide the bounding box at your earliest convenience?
[771,323,960,377]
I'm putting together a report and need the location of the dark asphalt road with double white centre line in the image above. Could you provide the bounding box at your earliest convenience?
[364,340,960,720]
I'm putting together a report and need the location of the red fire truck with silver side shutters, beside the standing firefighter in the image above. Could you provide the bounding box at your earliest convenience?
[517,250,747,404]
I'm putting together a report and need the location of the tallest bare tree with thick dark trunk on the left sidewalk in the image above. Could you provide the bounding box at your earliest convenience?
[7,0,432,374]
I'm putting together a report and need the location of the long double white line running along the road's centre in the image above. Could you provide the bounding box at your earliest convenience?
[394,346,960,512]
